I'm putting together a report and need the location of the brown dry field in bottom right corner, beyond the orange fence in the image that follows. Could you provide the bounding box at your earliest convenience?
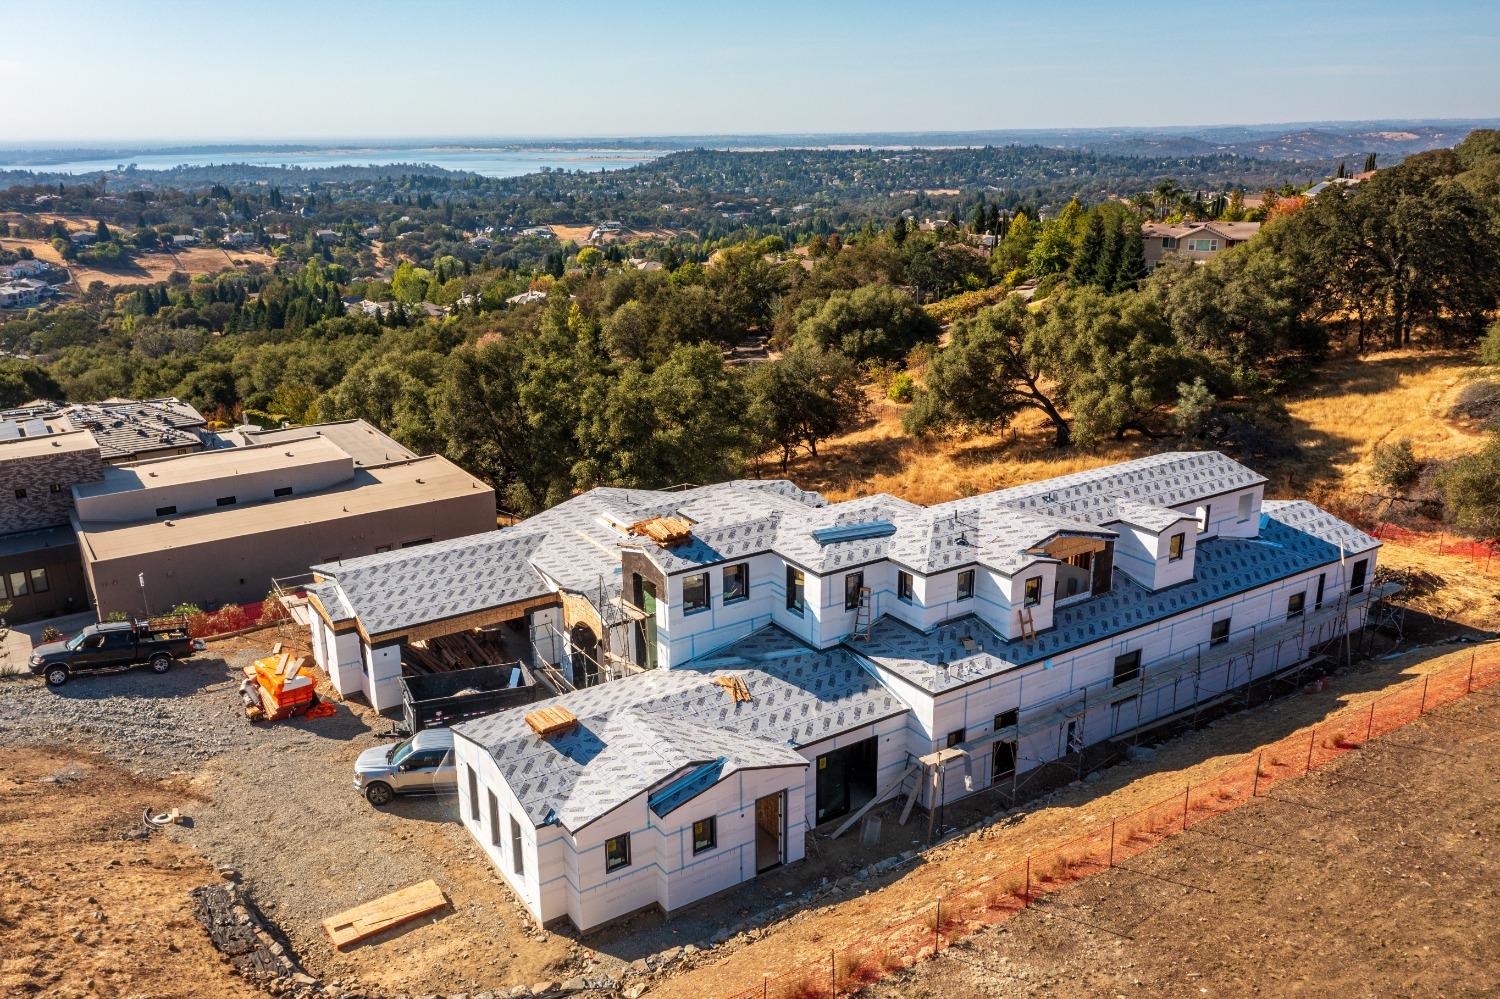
[861,690,1500,999]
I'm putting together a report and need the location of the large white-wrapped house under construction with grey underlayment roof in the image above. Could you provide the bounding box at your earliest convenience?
[308,452,1386,930]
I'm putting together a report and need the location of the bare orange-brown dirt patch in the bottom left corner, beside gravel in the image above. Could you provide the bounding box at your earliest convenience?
[0,747,261,999]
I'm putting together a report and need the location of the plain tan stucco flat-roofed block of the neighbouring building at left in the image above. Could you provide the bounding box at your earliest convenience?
[74,434,495,617]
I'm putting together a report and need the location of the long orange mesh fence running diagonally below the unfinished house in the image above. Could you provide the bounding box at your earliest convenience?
[726,648,1500,999]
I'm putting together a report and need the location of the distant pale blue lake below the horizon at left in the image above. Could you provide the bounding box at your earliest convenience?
[0,146,666,177]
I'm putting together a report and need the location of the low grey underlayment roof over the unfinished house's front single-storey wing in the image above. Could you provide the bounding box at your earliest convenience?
[455,627,906,831]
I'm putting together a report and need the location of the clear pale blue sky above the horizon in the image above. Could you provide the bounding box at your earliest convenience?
[0,0,1500,146]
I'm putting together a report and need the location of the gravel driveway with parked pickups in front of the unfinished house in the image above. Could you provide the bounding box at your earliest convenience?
[0,642,579,995]
